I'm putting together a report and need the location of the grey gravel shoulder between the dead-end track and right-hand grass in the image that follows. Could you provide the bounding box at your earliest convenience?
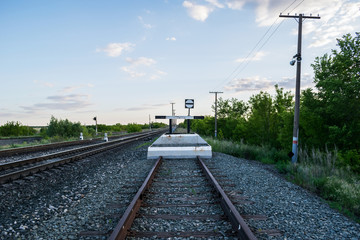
[205,152,360,240]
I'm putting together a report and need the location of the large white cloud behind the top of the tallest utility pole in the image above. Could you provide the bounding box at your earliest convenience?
[252,0,360,48]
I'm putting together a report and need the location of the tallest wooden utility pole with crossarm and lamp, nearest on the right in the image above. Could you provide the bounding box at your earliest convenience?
[279,14,320,163]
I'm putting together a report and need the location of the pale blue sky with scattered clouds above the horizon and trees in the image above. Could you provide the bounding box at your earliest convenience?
[0,0,360,126]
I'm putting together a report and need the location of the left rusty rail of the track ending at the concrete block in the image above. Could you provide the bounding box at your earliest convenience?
[109,157,162,240]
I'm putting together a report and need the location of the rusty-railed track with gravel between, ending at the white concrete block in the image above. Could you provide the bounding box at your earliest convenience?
[107,157,256,239]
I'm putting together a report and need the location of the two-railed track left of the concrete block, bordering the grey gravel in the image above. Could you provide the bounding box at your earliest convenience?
[0,130,164,184]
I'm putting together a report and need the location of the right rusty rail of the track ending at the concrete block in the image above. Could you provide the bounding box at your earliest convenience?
[197,157,257,240]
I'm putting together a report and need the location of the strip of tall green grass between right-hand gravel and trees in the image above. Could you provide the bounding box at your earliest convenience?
[205,138,360,223]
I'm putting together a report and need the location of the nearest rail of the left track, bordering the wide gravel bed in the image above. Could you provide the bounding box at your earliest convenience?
[0,131,165,184]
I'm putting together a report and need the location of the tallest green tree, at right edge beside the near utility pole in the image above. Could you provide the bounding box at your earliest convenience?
[307,33,360,149]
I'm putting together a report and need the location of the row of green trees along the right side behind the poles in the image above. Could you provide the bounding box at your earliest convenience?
[187,33,360,173]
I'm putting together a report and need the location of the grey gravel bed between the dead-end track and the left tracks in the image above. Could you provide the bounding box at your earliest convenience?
[0,138,155,239]
